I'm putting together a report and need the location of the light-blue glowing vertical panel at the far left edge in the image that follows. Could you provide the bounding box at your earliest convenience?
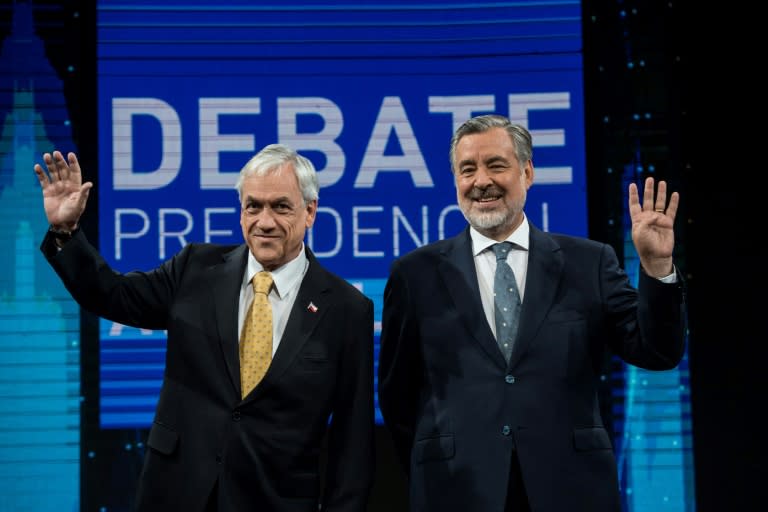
[0,2,80,512]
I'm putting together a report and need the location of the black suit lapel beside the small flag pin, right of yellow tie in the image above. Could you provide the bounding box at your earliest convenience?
[248,247,331,399]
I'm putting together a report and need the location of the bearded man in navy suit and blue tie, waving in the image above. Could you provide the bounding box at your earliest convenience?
[379,115,685,512]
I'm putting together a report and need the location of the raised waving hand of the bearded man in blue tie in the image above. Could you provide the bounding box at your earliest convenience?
[629,178,680,277]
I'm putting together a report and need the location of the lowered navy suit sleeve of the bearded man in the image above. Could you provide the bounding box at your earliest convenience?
[378,263,423,474]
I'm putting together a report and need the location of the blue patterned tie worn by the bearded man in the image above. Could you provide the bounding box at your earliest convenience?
[492,242,520,361]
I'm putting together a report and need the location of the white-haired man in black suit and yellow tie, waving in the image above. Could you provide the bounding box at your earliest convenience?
[35,145,374,512]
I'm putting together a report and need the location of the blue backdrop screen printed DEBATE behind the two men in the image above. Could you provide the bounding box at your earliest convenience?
[98,1,586,428]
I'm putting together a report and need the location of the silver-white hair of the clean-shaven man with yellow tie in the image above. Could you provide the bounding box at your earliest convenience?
[235,144,320,205]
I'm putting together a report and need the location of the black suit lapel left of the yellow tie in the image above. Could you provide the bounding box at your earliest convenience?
[206,244,248,396]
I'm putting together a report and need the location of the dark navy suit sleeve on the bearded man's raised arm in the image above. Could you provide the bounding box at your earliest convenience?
[601,245,686,370]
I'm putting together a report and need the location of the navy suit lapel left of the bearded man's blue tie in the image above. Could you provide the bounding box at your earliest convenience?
[438,228,507,368]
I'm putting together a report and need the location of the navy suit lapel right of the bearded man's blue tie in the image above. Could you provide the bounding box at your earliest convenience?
[509,224,564,367]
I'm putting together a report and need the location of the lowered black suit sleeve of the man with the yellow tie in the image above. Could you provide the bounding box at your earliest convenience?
[322,297,375,512]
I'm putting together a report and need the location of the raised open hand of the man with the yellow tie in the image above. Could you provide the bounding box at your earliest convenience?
[35,151,93,231]
